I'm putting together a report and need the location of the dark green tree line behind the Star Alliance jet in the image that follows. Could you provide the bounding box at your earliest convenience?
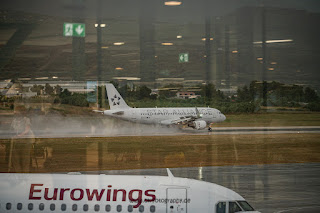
[1,81,320,113]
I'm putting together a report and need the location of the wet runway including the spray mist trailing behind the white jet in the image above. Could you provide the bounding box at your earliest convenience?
[0,116,320,139]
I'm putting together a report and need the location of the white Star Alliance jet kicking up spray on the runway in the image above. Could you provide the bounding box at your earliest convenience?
[94,84,226,131]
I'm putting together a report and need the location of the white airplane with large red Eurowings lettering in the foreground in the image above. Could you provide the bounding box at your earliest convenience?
[0,169,257,213]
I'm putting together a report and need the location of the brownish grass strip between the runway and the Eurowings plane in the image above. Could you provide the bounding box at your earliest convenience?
[0,134,320,172]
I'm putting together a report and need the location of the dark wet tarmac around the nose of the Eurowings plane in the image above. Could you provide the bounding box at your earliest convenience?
[85,163,320,213]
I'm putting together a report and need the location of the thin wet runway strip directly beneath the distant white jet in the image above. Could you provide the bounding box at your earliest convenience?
[0,125,320,139]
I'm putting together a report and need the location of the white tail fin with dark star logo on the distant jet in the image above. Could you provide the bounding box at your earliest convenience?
[106,84,130,110]
